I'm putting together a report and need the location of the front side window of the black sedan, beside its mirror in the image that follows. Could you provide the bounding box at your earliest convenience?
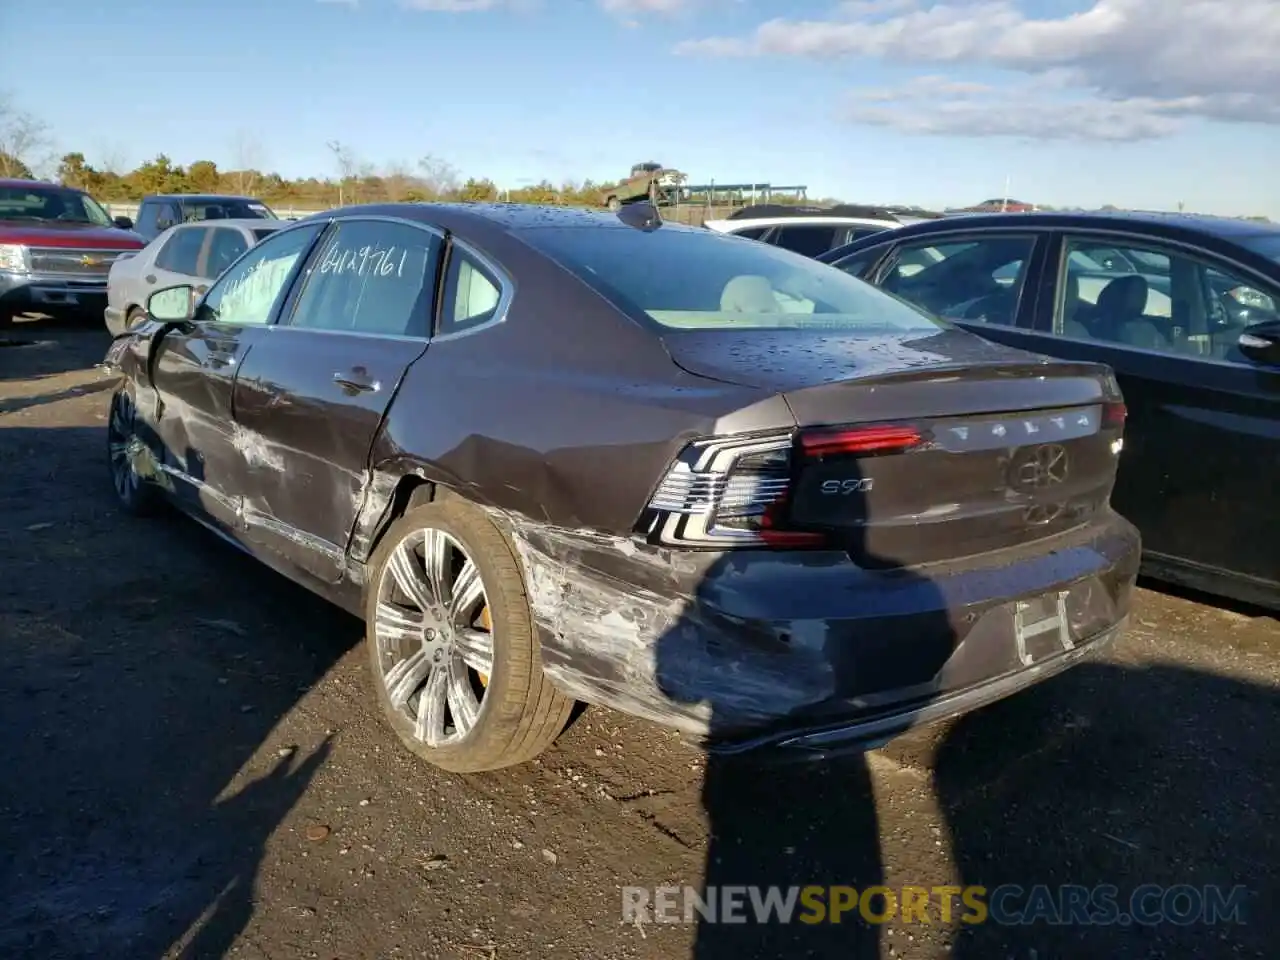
[1053,238,1280,362]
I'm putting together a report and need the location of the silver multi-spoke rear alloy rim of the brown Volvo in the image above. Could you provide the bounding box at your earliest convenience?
[372,527,494,746]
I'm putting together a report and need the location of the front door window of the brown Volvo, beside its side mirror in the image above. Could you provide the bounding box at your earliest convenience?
[197,224,323,325]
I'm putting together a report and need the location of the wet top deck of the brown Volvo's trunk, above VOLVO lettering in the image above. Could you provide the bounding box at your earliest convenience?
[663,328,1110,425]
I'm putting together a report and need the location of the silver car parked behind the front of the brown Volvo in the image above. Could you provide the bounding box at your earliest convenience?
[105,220,284,337]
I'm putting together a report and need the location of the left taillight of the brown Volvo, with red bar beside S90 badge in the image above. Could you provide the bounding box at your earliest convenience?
[640,426,925,548]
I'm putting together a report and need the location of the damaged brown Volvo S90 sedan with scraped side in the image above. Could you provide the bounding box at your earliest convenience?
[106,204,1139,771]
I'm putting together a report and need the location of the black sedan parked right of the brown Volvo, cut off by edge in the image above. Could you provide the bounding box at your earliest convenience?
[820,214,1280,608]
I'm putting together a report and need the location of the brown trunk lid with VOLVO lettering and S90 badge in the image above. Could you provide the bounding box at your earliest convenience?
[667,330,1124,568]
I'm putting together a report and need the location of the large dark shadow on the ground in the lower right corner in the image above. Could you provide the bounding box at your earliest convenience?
[931,660,1280,960]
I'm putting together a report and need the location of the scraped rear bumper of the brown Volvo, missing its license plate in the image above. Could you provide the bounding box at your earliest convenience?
[506,512,1140,754]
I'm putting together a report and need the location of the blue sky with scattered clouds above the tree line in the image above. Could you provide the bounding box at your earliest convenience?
[0,0,1280,219]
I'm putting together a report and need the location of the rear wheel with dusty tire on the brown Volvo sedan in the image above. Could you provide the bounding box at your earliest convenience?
[365,497,575,773]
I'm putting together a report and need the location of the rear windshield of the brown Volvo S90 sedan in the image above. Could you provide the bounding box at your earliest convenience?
[522,227,947,332]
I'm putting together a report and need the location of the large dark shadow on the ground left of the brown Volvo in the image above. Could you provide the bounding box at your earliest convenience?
[0,421,362,960]
